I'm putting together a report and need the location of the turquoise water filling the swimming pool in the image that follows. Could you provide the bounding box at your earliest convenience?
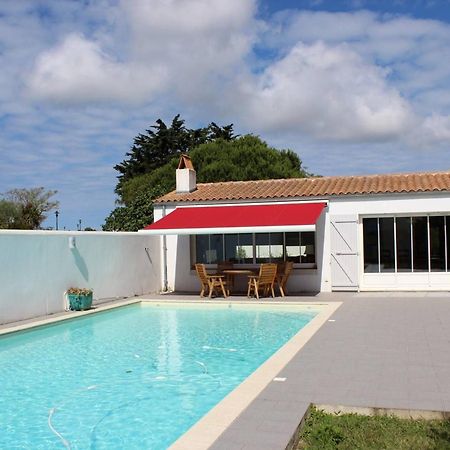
[0,304,317,450]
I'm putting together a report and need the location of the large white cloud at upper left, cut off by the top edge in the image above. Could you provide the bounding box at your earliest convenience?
[28,0,256,104]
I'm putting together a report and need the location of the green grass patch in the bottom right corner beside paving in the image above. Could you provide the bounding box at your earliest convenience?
[297,408,450,450]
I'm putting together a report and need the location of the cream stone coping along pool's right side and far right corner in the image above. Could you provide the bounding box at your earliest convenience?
[169,301,342,450]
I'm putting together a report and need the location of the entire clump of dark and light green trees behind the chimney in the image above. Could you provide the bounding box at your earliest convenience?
[103,115,311,231]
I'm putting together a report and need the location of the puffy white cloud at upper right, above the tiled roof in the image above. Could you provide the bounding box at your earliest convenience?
[237,43,414,140]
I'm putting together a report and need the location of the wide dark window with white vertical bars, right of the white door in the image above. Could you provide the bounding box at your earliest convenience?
[363,216,450,273]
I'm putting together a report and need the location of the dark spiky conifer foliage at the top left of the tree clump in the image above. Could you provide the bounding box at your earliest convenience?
[114,114,235,197]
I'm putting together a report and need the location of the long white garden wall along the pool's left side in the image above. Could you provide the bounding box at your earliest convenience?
[0,230,161,323]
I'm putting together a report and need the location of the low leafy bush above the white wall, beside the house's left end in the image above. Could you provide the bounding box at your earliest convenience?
[102,186,167,231]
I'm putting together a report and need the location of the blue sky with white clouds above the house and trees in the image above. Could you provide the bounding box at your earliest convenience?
[0,0,450,230]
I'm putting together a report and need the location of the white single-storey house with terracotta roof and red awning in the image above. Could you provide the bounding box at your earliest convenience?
[142,156,450,292]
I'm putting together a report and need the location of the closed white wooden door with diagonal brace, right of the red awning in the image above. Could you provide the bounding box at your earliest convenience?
[330,216,358,291]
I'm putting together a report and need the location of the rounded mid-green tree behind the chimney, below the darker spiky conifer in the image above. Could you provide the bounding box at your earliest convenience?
[103,135,310,231]
